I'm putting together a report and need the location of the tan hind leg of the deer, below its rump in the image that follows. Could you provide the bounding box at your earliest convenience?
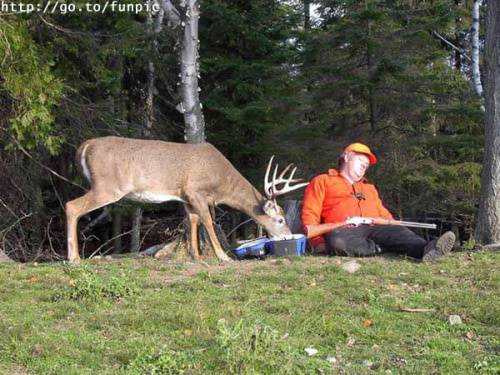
[66,190,122,264]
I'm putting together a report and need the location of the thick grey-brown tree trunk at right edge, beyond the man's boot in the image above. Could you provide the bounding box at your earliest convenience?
[475,1,500,244]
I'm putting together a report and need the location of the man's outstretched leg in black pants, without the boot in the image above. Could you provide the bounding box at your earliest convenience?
[368,225,427,259]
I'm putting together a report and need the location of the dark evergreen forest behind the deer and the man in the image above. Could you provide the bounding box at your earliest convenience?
[0,0,490,261]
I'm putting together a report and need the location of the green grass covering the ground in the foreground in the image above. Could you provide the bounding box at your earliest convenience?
[0,250,500,375]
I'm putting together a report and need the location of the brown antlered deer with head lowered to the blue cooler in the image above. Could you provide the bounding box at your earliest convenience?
[65,137,308,264]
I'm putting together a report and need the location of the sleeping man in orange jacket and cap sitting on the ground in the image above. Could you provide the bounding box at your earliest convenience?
[302,143,455,262]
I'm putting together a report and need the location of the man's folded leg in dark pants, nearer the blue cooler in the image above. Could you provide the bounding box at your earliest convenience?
[327,226,381,257]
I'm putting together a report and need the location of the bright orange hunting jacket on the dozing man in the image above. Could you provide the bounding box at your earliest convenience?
[302,169,393,247]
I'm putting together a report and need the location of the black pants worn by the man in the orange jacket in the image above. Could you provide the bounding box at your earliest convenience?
[328,225,427,259]
